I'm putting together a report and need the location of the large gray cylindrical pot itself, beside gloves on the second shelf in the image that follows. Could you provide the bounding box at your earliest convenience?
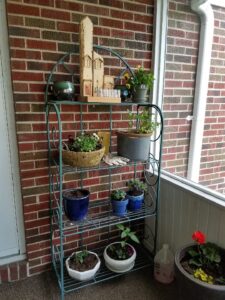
[117,131,151,161]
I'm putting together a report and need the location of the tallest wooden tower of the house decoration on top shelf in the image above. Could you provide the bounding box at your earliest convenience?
[80,17,93,96]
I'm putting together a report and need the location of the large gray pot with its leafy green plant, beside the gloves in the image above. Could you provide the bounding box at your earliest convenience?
[117,108,159,161]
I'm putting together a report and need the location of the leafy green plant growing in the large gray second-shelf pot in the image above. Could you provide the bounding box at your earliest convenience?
[128,108,159,133]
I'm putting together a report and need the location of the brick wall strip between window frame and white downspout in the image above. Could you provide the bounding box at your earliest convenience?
[163,0,199,177]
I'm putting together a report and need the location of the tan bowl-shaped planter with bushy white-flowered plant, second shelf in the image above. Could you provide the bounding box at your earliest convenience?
[62,132,105,167]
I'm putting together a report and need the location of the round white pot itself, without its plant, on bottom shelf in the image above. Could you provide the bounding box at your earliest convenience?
[103,242,136,273]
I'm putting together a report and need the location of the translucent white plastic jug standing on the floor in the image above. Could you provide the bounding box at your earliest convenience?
[154,244,174,283]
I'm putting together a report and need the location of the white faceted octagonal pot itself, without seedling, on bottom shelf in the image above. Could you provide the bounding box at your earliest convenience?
[66,251,101,281]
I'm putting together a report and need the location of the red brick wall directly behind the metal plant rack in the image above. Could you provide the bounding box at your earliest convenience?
[3,0,154,279]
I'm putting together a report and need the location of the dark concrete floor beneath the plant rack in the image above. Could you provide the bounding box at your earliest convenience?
[0,269,178,300]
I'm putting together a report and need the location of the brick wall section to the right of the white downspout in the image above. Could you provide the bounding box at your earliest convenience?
[199,7,225,194]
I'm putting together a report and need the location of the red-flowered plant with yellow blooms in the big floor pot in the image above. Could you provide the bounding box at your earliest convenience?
[183,231,225,285]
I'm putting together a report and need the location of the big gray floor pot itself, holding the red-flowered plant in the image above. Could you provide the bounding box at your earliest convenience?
[175,245,225,300]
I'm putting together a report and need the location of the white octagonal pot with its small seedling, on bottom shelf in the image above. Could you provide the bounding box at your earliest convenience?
[66,250,101,281]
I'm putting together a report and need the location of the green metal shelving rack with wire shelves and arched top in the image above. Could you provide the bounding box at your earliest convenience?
[45,50,163,300]
